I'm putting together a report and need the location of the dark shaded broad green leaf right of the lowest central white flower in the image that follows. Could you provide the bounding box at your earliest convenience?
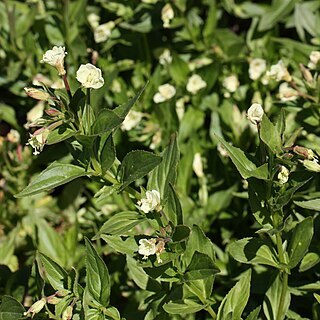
[183,251,220,281]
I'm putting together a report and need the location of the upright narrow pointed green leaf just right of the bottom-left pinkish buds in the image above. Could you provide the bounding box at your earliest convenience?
[85,238,110,307]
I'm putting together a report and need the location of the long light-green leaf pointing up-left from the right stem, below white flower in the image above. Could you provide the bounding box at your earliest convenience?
[215,134,268,180]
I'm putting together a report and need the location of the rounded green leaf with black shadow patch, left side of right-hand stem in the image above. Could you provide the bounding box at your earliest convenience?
[228,238,279,267]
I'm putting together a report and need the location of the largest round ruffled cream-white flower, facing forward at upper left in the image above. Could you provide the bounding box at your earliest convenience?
[77,63,104,89]
